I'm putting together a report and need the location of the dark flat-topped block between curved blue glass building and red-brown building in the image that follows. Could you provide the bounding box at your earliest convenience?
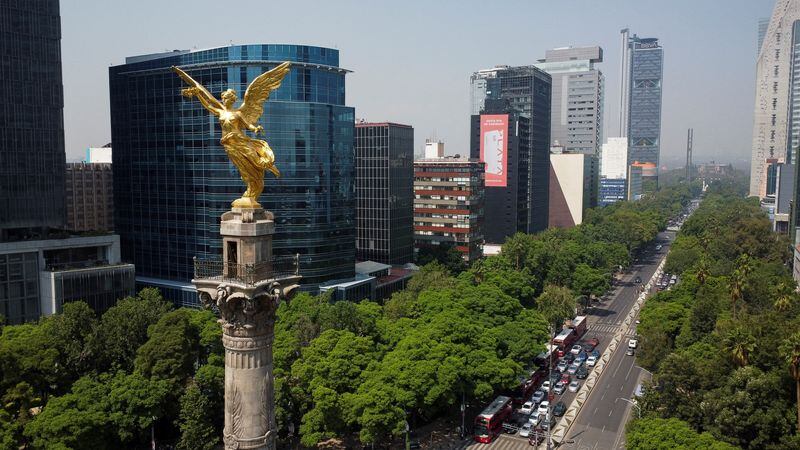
[355,123,414,264]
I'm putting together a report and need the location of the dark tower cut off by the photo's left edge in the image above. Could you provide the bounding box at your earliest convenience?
[0,0,66,242]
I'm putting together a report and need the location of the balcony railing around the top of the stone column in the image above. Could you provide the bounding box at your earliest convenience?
[194,255,300,286]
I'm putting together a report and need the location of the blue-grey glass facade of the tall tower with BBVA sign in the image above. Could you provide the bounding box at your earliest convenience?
[628,34,664,178]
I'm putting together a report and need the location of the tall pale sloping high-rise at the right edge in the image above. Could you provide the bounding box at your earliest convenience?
[750,0,800,199]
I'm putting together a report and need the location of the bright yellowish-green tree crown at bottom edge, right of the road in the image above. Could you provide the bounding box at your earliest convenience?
[625,418,736,450]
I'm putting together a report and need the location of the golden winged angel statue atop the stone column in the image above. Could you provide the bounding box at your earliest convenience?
[172,62,289,209]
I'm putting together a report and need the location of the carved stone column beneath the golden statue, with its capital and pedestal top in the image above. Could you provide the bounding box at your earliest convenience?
[192,208,300,450]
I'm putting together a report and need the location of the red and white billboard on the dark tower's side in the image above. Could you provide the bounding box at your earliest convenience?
[481,114,508,187]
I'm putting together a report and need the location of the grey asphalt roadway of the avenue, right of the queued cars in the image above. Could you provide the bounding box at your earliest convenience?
[562,232,675,450]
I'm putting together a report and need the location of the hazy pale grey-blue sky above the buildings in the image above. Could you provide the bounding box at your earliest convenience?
[61,0,774,166]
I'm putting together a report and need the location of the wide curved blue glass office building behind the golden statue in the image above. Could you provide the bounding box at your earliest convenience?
[109,44,355,305]
